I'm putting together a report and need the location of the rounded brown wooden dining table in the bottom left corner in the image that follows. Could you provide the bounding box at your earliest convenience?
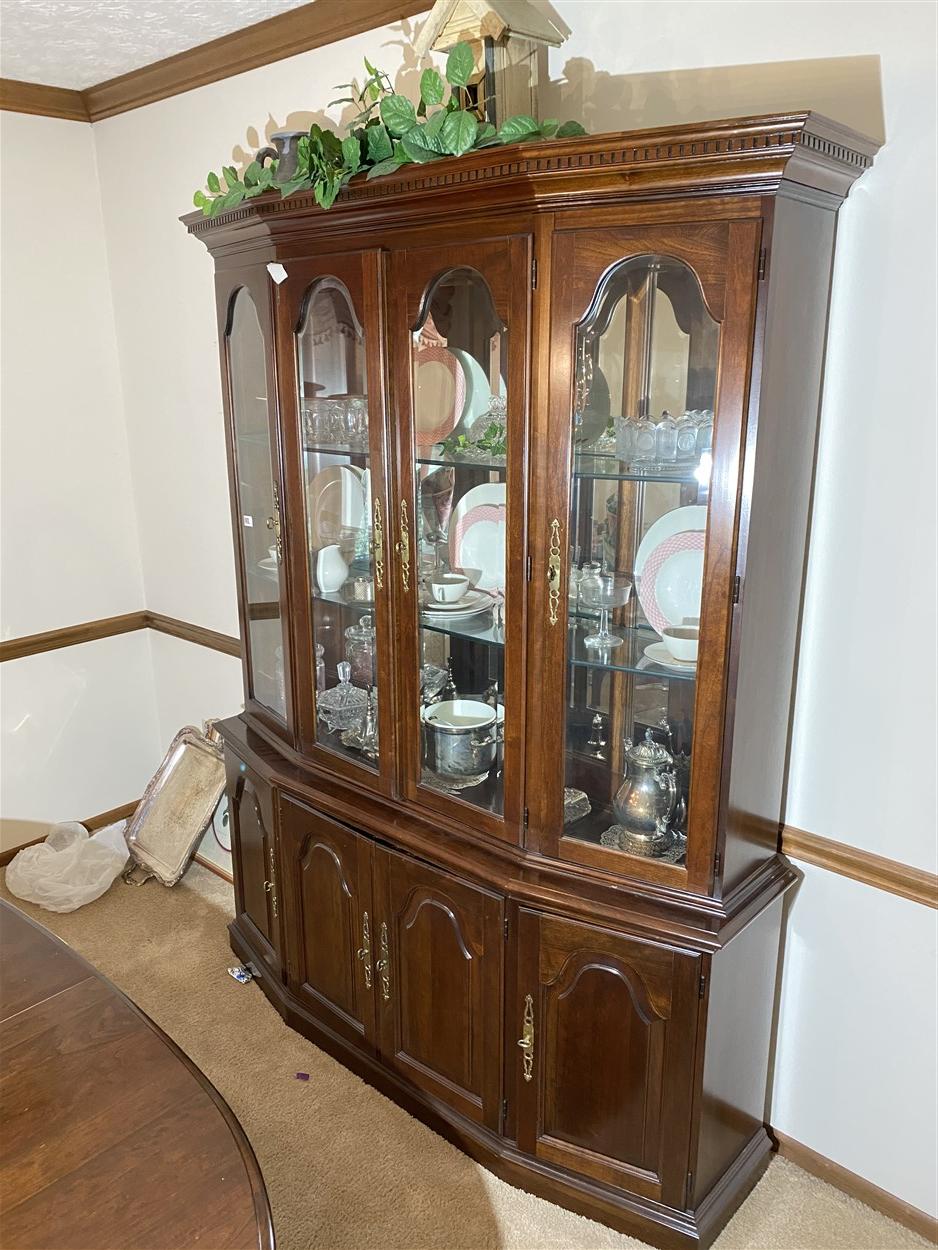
[0,900,274,1250]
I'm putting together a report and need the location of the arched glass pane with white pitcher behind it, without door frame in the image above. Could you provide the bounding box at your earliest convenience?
[296,278,379,769]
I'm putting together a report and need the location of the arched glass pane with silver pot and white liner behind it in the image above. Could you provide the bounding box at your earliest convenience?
[411,268,509,815]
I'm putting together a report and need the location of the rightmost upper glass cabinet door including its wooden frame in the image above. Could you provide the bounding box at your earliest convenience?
[530,224,752,884]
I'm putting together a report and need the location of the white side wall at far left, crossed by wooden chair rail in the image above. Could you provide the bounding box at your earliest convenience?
[0,113,158,849]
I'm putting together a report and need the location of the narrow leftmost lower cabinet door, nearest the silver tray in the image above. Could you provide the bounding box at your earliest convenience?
[225,753,281,979]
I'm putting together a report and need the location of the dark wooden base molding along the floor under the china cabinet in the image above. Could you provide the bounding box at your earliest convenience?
[229,921,773,1250]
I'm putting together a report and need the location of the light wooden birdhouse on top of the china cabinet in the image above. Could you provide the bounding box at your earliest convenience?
[414,0,570,126]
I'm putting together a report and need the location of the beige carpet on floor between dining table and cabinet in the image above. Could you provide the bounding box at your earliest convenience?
[1,865,928,1250]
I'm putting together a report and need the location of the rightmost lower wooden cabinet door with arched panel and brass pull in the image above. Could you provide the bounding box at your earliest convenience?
[508,910,700,1208]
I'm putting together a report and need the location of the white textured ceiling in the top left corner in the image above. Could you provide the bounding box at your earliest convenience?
[0,0,313,90]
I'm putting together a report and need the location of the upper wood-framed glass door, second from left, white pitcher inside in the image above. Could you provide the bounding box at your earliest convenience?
[278,254,393,789]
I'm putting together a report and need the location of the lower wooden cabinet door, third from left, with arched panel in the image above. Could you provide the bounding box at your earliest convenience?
[375,848,504,1130]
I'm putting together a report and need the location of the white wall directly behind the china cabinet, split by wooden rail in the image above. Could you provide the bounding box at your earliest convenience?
[3,0,938,1213]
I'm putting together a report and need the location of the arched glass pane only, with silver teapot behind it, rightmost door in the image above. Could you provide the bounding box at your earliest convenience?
[564,255,719,864]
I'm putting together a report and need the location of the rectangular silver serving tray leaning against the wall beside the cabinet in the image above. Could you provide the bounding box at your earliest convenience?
[124,725,225,885]
